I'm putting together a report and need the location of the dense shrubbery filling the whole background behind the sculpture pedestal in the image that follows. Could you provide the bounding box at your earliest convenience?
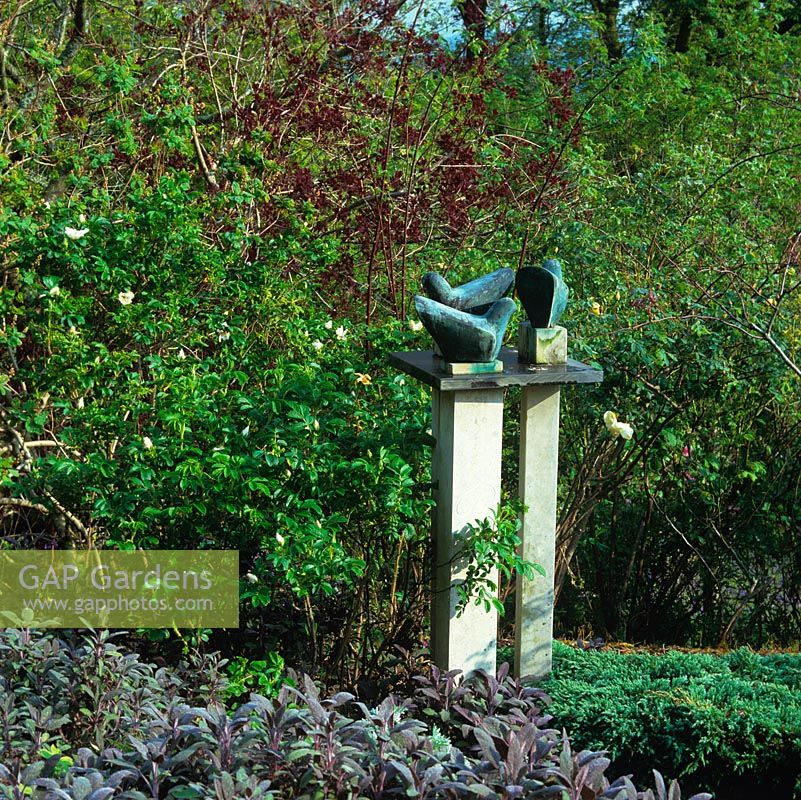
[0,0,801,708]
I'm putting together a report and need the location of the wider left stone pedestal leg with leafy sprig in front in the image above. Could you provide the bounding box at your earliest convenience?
[431,389,503,674]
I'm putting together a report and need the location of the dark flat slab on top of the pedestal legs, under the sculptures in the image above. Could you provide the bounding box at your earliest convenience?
[389,347,604,392]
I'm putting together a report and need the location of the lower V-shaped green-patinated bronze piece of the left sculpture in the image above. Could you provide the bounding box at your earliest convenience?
[414,296,515,363]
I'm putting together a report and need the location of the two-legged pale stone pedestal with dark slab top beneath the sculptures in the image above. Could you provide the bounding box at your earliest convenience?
[389,348,603,678]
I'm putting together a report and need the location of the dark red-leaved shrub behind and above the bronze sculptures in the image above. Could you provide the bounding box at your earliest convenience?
[42,0,580,320]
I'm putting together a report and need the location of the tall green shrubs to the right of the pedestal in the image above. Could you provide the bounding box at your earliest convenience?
[547,3,801,646]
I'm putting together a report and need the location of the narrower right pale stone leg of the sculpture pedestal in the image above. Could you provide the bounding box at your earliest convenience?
[515,386,559,678]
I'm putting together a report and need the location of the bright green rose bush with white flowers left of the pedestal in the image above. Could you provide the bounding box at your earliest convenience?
[0,169,438,680]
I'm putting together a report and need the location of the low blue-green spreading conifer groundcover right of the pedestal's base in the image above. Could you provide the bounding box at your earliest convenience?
[543,642,801,798]
